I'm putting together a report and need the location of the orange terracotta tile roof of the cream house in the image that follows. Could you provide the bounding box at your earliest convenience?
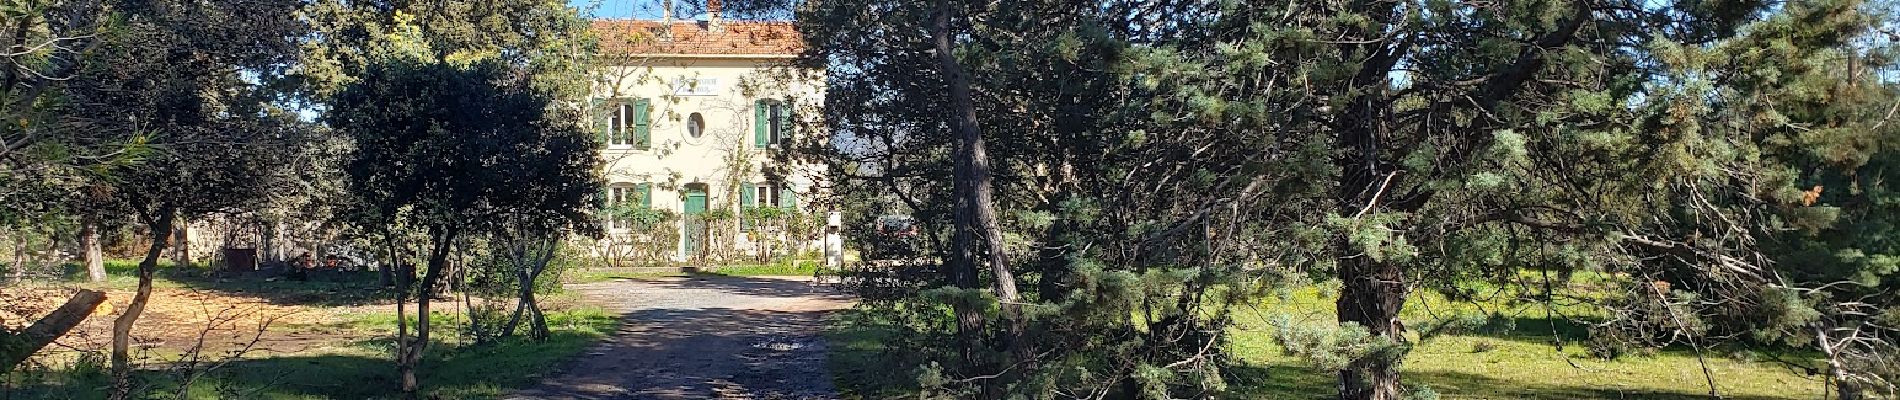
[593,19,806,55]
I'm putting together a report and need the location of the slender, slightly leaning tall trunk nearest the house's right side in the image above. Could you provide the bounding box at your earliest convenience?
[933,0,1030,375]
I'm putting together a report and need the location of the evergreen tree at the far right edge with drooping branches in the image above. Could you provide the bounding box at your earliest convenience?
[1596,2,1900,398]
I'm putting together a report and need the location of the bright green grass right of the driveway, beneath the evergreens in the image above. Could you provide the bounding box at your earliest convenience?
[827,288,1822,400]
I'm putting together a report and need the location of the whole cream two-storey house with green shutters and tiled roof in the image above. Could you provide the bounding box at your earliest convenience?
[589,2,825,264]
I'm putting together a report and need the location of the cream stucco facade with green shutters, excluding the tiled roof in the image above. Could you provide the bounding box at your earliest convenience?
[589,25,825,260]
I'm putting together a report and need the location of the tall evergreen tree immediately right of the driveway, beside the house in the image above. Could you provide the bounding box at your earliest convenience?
[800,2,1324,398]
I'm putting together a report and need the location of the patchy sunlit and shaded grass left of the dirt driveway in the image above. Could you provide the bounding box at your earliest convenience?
[11,262,619,400]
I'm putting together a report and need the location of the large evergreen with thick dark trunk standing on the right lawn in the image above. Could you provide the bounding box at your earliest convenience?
[1162,0,1816,398]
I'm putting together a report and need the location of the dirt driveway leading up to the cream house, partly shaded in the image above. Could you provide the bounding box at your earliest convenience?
[509,277,849,400]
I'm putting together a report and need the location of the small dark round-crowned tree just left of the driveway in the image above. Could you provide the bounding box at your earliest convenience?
[325,59,600,398]
